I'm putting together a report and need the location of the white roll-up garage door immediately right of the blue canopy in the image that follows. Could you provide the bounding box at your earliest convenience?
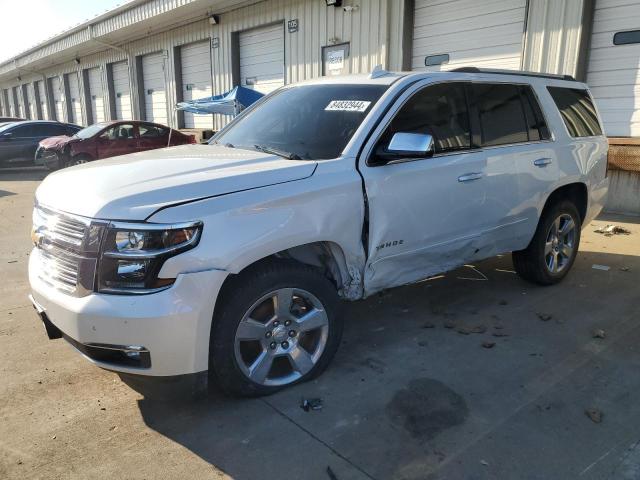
[240,23,284,94]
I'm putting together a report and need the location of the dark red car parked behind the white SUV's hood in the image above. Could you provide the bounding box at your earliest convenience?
[36,120,196,170]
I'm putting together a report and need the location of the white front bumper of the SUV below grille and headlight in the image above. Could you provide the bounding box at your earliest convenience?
[29,251,227,376]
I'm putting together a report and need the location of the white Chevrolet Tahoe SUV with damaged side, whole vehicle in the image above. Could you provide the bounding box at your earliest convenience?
[29,68,608,395]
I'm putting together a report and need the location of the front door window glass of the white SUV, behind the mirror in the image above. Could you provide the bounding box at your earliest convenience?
[378,83,471,153]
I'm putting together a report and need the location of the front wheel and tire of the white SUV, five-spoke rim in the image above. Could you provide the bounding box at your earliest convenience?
[209,260,343,397]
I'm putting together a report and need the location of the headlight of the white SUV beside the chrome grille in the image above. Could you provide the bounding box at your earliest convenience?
[98,222,202,294]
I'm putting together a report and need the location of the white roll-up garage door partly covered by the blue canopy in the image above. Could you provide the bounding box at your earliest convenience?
[180,41,213,128]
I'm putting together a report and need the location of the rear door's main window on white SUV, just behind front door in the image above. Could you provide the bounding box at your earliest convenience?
[473,83,528,147]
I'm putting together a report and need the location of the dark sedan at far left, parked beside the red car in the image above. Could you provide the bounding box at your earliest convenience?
[0,120,82,167]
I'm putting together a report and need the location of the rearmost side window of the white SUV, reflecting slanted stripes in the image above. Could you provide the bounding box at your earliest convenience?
[547,87,602,137]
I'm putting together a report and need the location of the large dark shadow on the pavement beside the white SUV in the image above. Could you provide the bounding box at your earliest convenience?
[124,249,640,480]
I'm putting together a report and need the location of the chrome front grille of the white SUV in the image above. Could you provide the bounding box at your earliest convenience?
[32,205,95,296]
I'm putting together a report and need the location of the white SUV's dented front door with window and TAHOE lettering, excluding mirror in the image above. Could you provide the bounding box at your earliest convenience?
[359,82,491,294]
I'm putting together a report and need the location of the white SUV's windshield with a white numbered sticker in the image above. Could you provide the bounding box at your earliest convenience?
[213,84,388,160]
